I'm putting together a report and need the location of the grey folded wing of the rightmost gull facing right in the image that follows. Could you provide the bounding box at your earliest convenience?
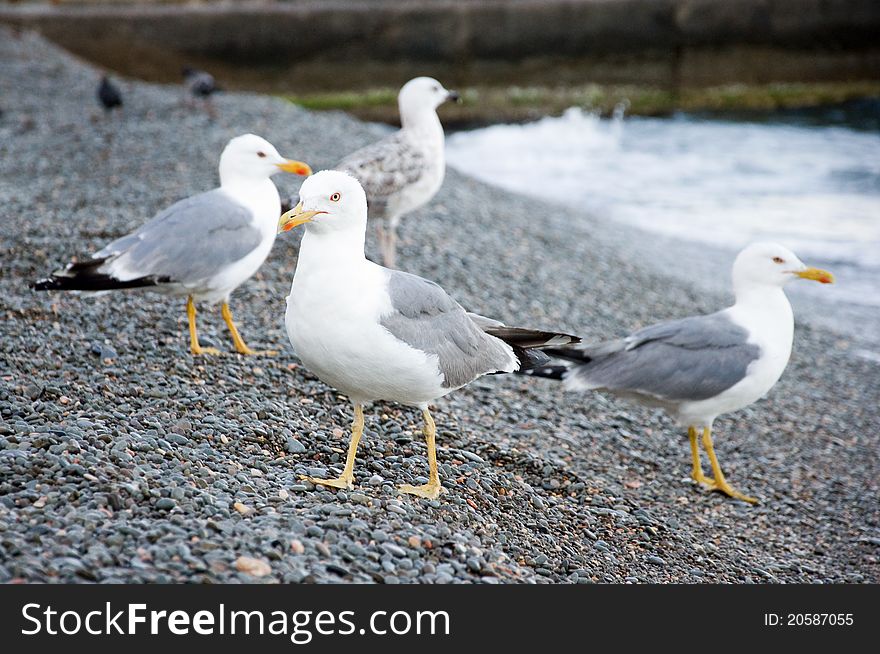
[560,312,761,401]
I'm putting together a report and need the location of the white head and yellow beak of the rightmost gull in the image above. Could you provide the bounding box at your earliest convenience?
[733,243,834,288]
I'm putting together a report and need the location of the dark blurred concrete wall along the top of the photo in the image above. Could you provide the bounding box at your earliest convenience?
[0,0,880,84]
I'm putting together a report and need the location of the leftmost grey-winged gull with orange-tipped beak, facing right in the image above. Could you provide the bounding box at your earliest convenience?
[32,134,311,354]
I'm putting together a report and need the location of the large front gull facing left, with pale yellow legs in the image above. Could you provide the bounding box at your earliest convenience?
[279,170,579,499]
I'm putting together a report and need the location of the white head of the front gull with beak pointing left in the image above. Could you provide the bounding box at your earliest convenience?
[278,170,367,233]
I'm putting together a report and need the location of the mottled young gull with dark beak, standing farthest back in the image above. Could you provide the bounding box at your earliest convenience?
[336,77,460,268]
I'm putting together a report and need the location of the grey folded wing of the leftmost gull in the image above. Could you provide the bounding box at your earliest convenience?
[93,189,262,283]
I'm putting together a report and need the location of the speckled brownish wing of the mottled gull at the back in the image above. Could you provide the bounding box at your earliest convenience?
[336,131,427,218]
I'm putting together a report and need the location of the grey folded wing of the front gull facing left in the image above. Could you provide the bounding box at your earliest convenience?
[381,270,517,388]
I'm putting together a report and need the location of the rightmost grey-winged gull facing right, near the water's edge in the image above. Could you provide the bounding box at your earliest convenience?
[525,243,834,503]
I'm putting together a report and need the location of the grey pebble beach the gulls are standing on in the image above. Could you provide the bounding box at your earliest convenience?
[0,32,880,583]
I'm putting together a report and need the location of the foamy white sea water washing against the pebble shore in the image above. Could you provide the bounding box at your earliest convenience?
[447,102,880,316]
